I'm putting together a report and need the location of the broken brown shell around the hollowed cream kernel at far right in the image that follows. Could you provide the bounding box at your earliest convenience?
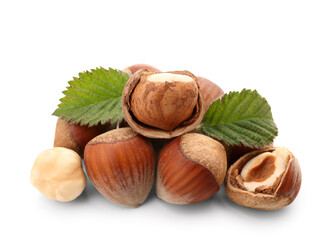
[225,147,302,210]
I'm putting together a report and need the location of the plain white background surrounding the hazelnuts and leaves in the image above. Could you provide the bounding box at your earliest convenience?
[0,0,333,239]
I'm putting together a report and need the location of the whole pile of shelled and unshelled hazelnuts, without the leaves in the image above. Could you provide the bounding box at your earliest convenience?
[31,64,301,210]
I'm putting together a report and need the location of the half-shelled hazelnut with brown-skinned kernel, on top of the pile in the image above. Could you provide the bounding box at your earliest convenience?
[122,69,204,138]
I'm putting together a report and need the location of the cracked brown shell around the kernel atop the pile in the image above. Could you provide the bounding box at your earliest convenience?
[122,69,205,138]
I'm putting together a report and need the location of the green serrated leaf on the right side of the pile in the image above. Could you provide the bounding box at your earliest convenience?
[199,89,278,147]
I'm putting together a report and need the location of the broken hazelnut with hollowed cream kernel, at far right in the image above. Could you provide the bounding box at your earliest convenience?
[226,147,302,210]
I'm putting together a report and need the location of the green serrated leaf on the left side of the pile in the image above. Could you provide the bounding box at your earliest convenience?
[53,68,129,126]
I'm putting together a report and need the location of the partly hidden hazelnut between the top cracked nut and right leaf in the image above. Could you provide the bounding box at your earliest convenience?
[197,77,224,112]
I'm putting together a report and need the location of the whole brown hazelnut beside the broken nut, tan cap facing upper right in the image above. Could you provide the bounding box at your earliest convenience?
[156,133,227,204]
